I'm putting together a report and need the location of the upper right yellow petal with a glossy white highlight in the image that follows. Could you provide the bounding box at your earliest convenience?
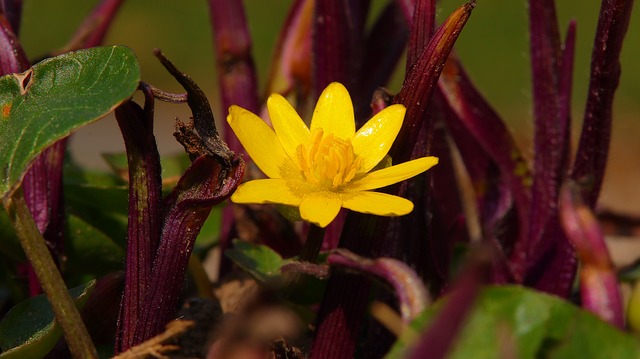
[353,105,406,172]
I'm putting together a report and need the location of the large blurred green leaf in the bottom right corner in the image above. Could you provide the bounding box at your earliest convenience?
[386,286,640,359]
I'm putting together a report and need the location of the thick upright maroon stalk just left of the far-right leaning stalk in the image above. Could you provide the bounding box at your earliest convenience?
[510,0,568,281]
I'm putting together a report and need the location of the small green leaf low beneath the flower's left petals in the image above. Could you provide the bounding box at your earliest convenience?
[224,240,288,282]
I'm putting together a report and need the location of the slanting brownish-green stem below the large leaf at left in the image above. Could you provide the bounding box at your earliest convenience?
[3,188,98,358]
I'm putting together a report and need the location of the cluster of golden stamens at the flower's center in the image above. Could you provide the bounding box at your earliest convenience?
[297,128,362,189]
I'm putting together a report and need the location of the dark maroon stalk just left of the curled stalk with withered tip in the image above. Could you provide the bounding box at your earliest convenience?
[116,91,162,353]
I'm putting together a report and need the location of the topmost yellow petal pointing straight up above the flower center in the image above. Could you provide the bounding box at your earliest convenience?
[311,82,356,140]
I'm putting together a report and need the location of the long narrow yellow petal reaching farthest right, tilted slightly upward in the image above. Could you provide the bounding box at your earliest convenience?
[347,157,438,191]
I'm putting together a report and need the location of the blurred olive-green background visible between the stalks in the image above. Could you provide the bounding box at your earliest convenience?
[21,0,640,211]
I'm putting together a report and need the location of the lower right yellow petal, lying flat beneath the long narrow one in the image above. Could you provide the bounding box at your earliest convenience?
[342,191,413,216]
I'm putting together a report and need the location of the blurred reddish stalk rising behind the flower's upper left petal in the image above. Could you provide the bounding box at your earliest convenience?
[209,0,260,155]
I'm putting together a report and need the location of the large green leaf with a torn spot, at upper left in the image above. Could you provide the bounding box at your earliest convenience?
[0,46,140,197]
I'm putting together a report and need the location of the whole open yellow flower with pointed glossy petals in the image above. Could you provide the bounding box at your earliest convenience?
[227,82,438,227]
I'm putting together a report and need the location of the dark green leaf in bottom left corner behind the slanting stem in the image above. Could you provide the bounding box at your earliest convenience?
[0,281,96,359]
